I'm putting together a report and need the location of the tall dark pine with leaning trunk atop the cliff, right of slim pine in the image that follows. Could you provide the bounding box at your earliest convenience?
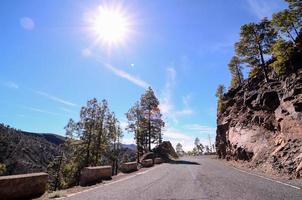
[235,18,277,82]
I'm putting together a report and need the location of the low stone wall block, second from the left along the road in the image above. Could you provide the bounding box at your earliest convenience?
[80,165,112,186]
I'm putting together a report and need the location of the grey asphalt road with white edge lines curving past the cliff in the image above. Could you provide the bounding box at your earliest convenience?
[67,157,302,200]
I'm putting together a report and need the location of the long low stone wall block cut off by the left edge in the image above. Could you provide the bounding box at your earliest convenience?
[0,173,48,200]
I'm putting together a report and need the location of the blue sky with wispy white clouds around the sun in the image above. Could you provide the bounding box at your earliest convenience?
[0,0,286,150]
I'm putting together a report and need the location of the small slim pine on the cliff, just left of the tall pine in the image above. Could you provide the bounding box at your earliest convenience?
[228,56,243,87]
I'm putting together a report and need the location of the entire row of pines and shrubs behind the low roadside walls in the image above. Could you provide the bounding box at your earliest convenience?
[48,88,164,191]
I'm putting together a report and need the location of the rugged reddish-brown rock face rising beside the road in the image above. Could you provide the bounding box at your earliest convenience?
[216,69,302,175]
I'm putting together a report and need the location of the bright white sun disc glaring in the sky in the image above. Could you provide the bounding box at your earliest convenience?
[91,6,130,45]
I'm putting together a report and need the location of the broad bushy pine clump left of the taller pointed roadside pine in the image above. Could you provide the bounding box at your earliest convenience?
[62,98,122,186]
